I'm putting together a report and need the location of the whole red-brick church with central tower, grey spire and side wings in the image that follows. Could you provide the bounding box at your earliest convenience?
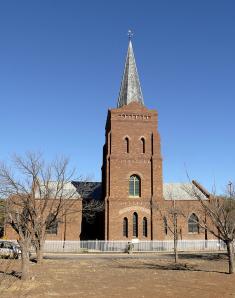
[6,40,211,240]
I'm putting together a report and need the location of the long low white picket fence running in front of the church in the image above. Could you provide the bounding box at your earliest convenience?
[41,240,226,253]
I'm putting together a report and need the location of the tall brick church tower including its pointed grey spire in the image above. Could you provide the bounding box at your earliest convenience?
[102,40,163,240]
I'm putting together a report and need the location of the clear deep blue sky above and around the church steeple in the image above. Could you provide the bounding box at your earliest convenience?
[0,0,235,190]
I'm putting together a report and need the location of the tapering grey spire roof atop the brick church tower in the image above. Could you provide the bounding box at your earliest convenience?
[117,40,144,108]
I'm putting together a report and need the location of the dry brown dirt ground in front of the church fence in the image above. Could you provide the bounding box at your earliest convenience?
[0,254,235,298]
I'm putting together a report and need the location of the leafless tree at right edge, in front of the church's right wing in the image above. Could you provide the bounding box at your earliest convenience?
[185,180,235,274]
